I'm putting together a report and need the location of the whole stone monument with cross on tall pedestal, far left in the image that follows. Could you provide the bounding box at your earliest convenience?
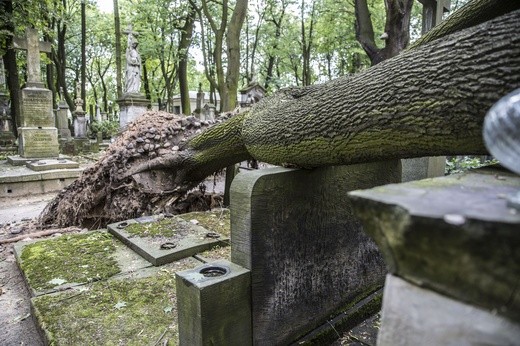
[8,29,59,165]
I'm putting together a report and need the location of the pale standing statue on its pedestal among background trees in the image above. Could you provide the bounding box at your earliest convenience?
[117,25,150,128]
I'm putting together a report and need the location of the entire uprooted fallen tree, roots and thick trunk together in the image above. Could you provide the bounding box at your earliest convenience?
[41,4,520,227]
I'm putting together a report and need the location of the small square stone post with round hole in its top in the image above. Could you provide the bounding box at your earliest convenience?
[176,260,252,346]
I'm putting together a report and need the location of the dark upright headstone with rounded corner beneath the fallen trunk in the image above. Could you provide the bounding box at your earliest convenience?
[231,160,401,345]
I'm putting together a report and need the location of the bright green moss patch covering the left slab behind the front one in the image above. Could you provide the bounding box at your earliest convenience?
[20,231,121,291]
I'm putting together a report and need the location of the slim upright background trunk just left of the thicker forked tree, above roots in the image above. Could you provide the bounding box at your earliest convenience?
[178,4,197,115]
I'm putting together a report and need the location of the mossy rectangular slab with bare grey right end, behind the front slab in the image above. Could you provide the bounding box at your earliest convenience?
[14,230,150,296]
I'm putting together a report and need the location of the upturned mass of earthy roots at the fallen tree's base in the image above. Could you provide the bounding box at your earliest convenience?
[40,111,235,228]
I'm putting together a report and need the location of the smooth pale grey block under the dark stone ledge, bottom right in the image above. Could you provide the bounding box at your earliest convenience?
[377,274,520,346]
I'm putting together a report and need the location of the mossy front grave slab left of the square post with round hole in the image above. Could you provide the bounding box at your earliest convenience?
[33,269,178,346]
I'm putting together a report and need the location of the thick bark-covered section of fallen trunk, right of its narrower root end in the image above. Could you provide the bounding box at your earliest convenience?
[242,11,520,167]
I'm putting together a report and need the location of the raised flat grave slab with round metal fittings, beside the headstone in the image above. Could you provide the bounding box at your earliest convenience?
[107,216,229,266]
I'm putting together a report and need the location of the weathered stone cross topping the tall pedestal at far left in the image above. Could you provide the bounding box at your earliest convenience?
[13,28,51,88]
